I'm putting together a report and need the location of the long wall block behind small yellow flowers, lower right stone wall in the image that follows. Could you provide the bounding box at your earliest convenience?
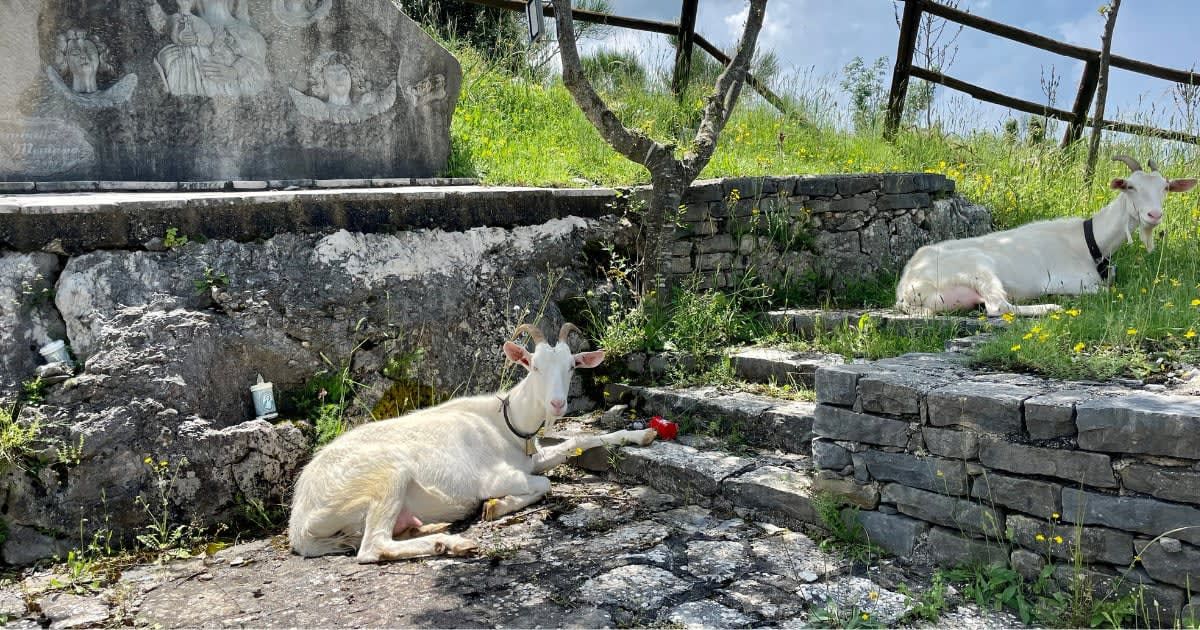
[1007,514,1133,566]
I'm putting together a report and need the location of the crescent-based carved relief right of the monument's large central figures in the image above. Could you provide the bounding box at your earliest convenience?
[288,52,396,125]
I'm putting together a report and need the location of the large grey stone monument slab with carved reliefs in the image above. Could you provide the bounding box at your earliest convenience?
[0,0,462,181]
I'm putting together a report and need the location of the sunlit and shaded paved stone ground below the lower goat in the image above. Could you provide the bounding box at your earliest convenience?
[0,456,1015,628]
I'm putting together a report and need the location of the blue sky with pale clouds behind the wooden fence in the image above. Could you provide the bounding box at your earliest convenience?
[588,0,1200,133]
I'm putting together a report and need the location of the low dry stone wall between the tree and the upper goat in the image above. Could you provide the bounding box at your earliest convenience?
[652,173,991,287]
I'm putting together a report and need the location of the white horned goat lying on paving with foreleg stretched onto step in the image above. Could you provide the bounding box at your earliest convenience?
[288,324,656,563]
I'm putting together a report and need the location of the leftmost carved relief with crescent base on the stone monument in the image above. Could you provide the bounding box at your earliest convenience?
[46,29,138,108]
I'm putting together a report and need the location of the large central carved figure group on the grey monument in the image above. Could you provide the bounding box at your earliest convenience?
[146,0,271,96]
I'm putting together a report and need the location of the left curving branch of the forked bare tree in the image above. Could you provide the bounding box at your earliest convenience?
[553,0,673,169]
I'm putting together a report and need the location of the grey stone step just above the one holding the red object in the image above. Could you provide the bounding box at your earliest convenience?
[608,385,816,455]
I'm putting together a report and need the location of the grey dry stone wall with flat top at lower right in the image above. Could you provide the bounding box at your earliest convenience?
[812,354,1200,625]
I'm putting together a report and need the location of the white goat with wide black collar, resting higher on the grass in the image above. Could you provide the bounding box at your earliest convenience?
[896,156,1196,317]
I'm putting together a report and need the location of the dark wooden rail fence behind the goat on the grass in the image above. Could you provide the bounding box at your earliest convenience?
[883,0,1200,146]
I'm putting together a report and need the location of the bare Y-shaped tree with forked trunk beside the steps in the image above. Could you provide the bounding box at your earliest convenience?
[553,0,767,296]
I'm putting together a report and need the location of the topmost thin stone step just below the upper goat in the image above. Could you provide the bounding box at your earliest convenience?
[763,308,988,337]
